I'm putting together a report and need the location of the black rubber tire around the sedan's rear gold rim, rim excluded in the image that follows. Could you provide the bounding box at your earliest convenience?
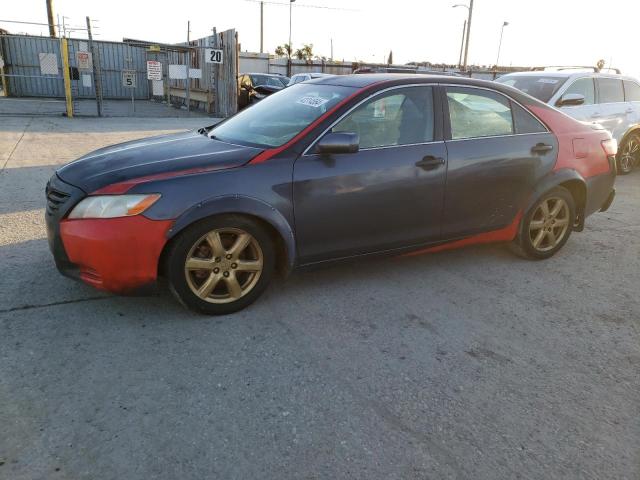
[511,187,576,260]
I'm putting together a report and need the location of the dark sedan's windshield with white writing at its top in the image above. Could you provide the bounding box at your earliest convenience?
[209,83,355,148]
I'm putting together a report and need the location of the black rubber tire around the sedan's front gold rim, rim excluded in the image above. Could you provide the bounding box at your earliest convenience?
[166,215,275,315]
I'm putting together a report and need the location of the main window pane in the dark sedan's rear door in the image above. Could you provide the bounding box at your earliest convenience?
[447,87,515,140]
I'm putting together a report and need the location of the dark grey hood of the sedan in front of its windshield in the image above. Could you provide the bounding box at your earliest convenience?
[56,131,262,193]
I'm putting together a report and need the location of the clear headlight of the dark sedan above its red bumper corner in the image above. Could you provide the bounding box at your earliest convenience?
[69,193,160,218]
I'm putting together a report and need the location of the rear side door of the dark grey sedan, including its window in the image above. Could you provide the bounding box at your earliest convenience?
[442,86,558,240]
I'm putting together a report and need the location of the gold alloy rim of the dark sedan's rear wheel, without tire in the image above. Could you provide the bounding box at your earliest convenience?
[529,197,570,252]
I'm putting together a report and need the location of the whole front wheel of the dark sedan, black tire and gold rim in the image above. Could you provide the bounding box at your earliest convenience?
[167,215,275,315]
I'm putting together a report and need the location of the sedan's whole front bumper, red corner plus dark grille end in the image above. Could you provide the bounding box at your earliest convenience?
[45,176,173,294]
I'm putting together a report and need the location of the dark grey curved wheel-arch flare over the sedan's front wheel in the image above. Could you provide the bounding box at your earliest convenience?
[167,195,297,269]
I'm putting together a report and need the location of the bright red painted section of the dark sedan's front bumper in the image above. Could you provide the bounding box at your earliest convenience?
[60,215,173,293]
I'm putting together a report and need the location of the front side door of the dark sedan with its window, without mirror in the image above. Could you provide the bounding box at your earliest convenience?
[293,86,446,263]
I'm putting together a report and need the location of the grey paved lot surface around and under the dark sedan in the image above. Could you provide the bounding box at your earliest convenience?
[0,117,640,480]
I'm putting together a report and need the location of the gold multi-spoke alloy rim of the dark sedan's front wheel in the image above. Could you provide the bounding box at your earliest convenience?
[184,228,263,303]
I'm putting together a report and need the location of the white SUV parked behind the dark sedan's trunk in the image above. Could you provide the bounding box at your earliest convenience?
[496,67,640,174]
